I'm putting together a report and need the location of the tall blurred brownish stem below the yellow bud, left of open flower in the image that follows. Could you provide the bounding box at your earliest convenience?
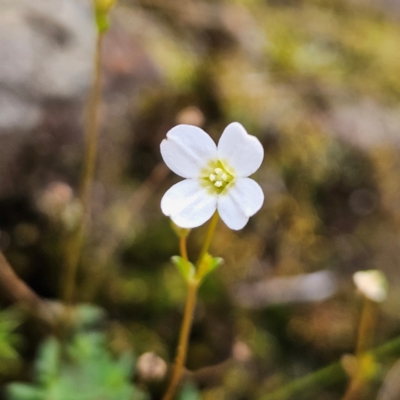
[62,33,103,305]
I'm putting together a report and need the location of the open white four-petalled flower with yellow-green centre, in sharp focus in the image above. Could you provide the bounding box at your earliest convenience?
[161,122,264,230]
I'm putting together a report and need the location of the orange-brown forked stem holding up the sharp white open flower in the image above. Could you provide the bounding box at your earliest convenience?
[163,216,219,400]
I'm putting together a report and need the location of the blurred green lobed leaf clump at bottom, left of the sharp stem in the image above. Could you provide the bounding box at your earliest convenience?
[8,331,147,400]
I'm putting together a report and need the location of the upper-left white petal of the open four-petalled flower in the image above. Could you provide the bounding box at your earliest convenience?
[161,125,217,178]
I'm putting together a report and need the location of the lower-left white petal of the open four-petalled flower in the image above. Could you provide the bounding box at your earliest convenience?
[161,179,217,228]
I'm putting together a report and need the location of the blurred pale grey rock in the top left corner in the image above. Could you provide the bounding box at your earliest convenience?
[0,0,95,133]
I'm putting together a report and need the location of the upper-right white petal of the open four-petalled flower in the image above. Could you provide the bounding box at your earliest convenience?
[218,122,264,177]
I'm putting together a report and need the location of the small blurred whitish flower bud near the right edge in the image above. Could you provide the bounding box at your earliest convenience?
[353,269,388,303]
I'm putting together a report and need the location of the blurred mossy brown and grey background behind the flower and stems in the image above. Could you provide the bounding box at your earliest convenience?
[0,0,400,400]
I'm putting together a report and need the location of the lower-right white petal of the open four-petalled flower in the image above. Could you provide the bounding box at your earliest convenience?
[218,178,264,230]
